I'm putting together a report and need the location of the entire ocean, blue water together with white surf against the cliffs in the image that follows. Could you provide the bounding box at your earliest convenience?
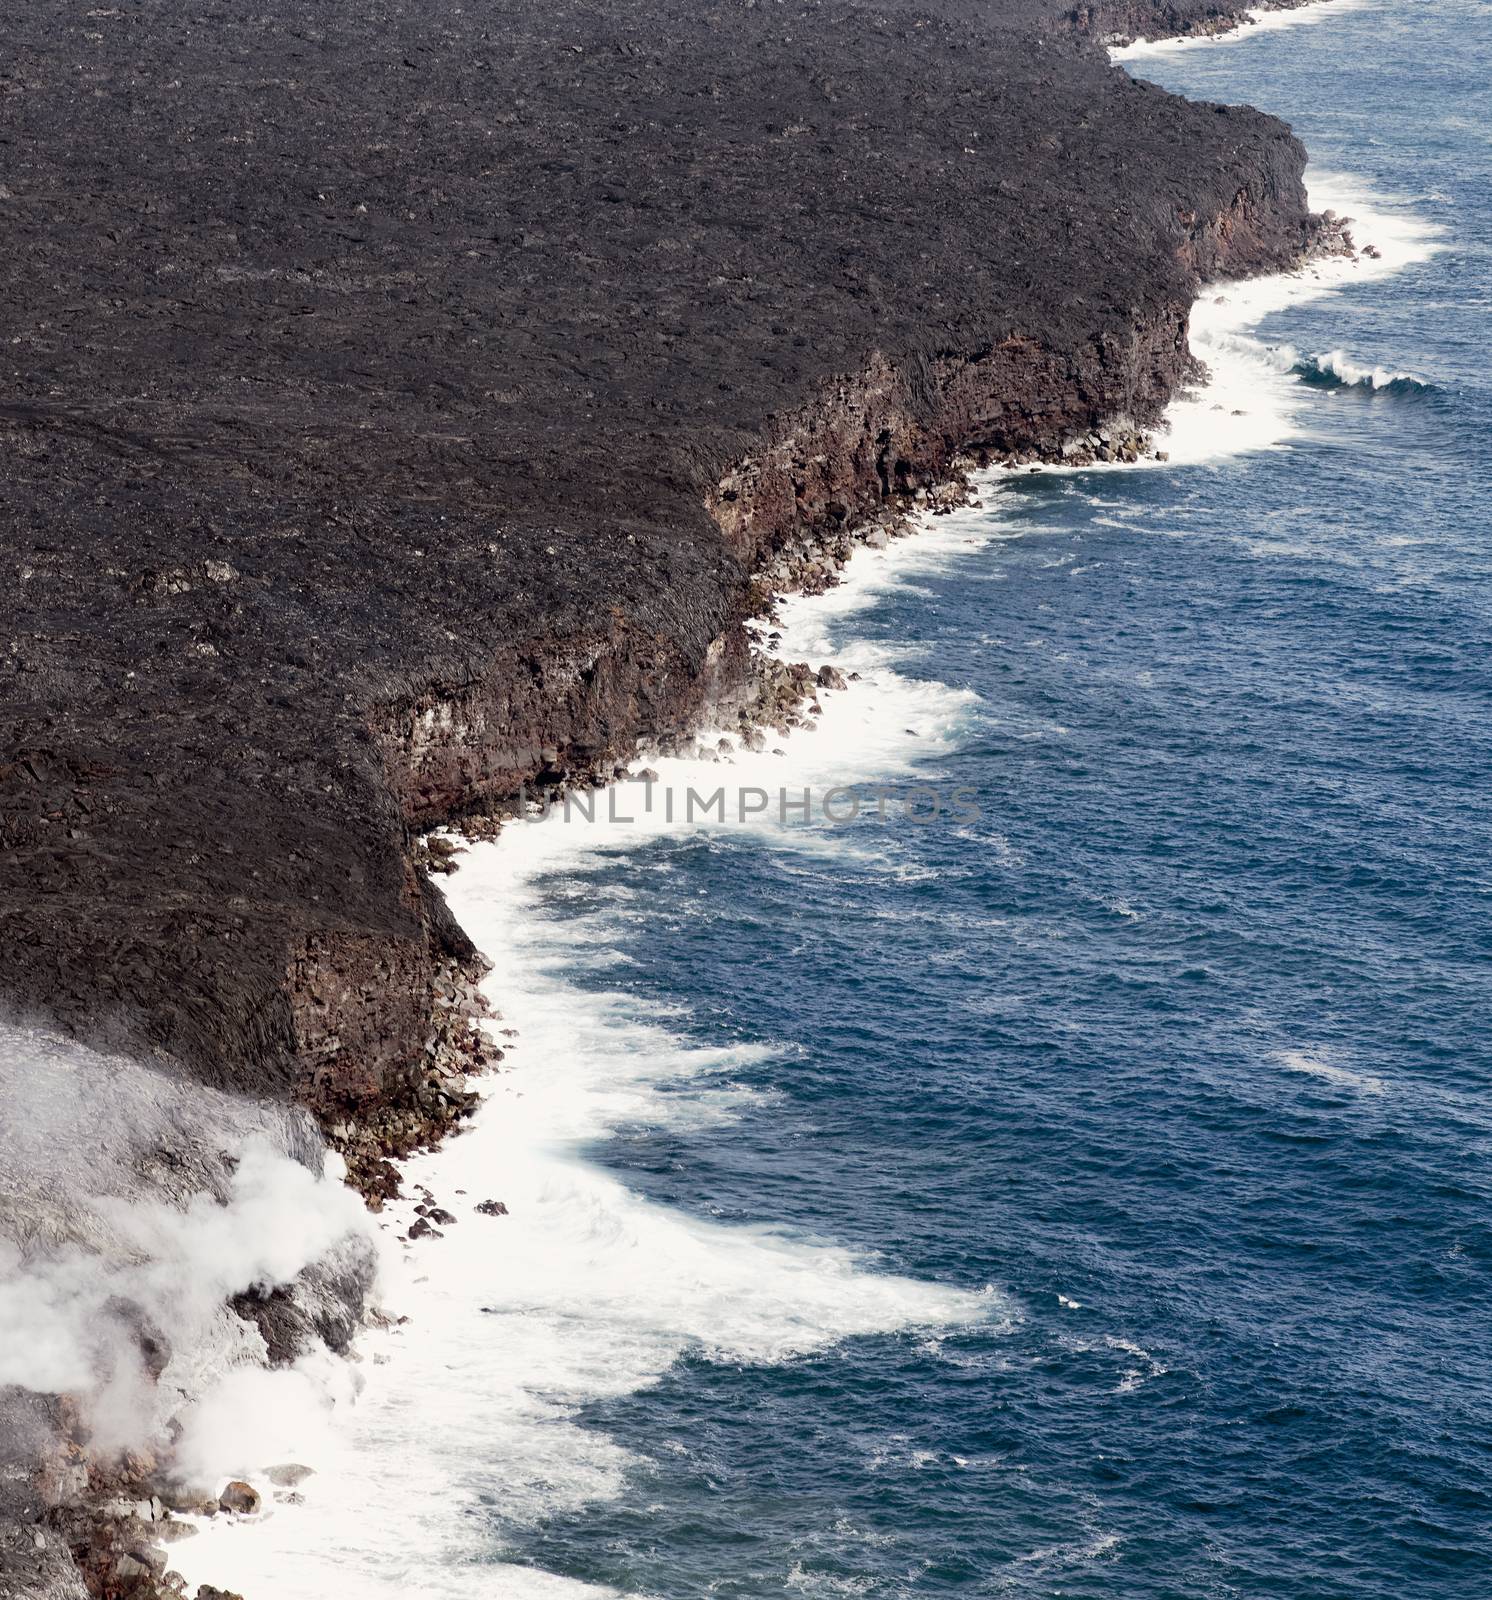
[173,0,1492,1600]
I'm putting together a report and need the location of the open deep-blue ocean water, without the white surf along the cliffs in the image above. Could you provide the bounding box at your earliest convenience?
[483,0,1492,1600]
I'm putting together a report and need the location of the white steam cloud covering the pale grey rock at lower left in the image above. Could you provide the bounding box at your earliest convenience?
[0,1024,375,1485]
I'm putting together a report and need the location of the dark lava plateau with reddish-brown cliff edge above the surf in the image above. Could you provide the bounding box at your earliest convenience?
[0,0,1331,1587]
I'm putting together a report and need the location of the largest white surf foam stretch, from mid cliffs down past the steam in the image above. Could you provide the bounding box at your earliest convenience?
[173,515,1005,1600]
